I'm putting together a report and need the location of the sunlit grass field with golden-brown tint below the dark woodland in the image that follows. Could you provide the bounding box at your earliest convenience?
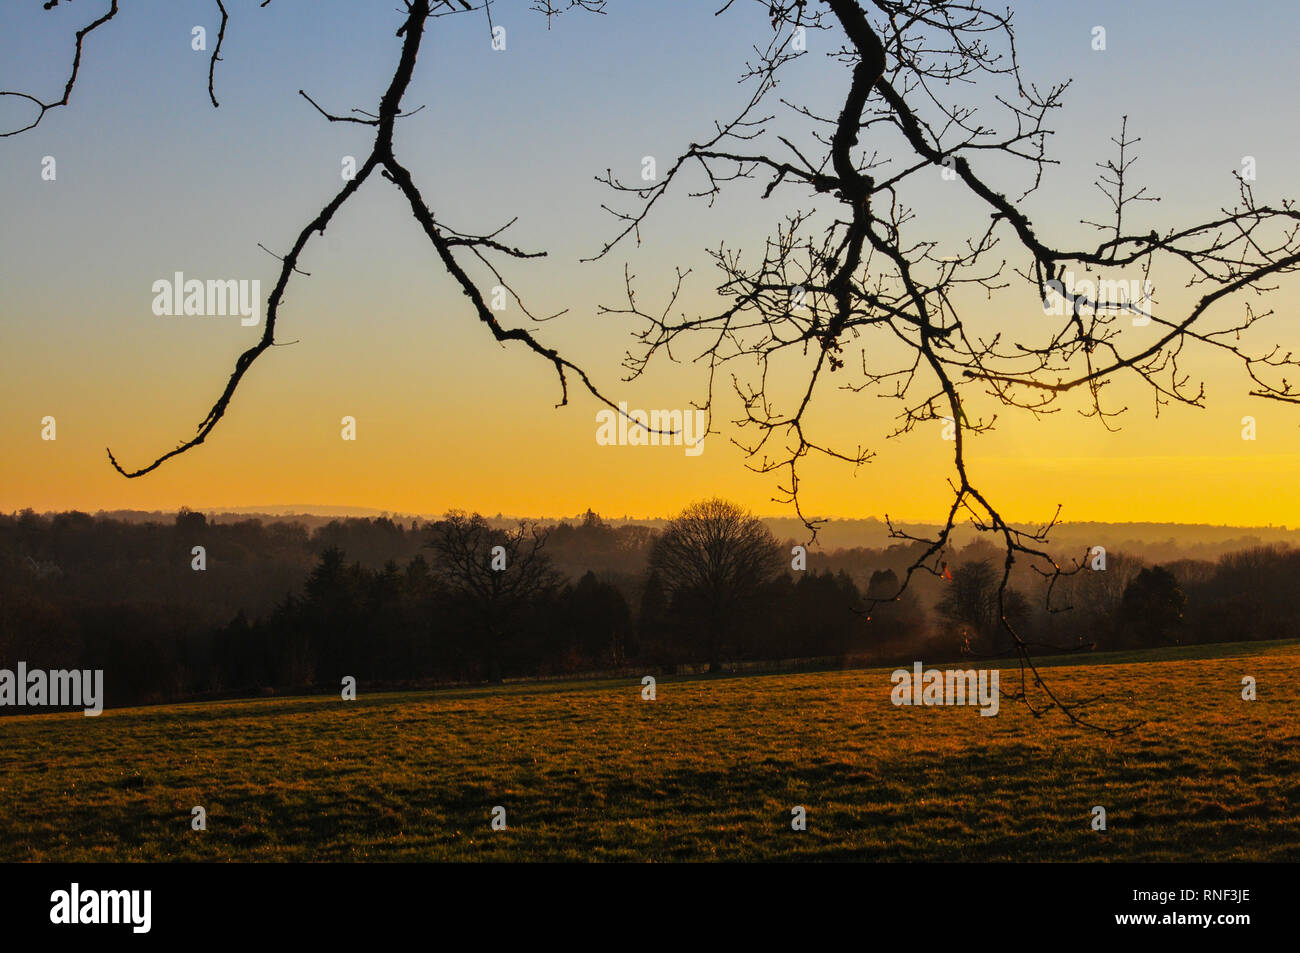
[0,641,1300,861]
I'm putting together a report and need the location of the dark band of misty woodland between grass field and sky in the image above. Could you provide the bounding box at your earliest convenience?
[0,499,1300,706]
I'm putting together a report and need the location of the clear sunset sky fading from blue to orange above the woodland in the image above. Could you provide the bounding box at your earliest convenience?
[0,0,1300,525]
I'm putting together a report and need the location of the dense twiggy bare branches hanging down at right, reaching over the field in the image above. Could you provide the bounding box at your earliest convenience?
[597,0,1300,731]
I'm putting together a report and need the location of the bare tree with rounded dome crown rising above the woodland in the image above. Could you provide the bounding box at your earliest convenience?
[650,498,781,672]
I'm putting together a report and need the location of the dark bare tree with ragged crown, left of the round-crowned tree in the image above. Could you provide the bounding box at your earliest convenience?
[428,512,563,681]
